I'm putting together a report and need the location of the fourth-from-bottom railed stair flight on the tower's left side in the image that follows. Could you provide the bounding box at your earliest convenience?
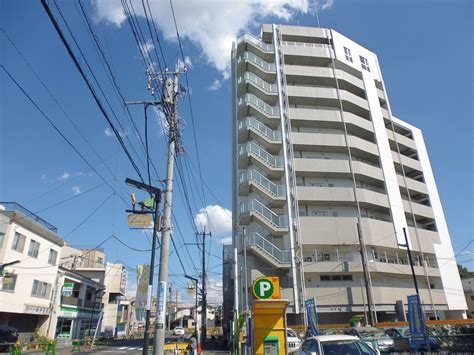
[239,142,284,177]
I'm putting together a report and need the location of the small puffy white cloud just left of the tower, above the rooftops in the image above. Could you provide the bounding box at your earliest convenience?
[194,205,232,236]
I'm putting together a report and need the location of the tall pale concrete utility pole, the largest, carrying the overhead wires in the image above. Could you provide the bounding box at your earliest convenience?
[153,67,178,355]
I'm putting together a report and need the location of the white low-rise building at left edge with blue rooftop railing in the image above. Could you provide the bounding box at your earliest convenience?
[0,202,64,342]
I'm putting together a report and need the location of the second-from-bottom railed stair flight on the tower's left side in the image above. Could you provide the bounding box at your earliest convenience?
[239,200,288,235]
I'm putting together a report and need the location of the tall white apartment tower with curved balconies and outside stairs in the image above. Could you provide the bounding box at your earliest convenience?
[230,24,467,324]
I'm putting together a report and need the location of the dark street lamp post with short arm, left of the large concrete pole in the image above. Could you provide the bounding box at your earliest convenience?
[124,178,161,355]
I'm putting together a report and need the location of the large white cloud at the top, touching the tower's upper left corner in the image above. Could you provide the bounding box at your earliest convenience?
[93,0,310,79]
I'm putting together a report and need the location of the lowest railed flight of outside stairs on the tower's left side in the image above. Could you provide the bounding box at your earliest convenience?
[246,233,291,268]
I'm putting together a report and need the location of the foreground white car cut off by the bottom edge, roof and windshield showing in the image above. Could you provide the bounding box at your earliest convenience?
[298,335,380,355]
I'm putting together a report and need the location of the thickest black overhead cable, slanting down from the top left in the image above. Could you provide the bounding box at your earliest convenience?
[41,0,144,182]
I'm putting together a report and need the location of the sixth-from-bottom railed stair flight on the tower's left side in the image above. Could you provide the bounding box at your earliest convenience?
[238,94,280,128]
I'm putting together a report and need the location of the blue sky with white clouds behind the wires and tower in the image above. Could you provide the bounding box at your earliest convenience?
[0,0,474,304]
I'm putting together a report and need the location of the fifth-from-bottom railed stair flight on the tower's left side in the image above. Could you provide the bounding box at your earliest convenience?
[239,116,282,154]
